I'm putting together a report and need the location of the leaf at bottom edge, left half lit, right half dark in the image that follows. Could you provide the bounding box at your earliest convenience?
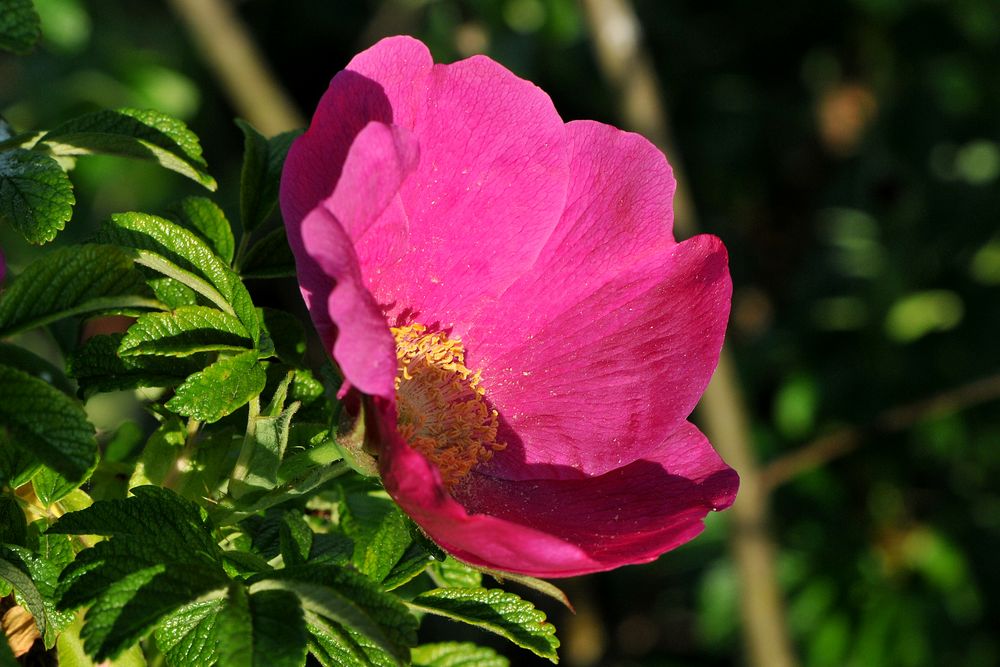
[219,585,307,667]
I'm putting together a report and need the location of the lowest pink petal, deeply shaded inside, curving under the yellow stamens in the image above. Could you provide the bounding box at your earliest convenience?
[382,414,738,577]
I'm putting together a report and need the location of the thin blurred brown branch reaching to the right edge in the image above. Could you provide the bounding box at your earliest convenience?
[761,374,1000,492]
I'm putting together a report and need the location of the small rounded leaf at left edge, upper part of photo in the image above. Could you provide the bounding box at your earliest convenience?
[0,149,76,244]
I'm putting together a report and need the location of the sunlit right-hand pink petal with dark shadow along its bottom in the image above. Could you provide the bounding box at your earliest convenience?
[467,236,732,479]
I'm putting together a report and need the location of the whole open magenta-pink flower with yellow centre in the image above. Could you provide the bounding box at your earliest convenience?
[281,37,738,577]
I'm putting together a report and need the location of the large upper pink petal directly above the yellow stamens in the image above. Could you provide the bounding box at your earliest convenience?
[354,49,568,328]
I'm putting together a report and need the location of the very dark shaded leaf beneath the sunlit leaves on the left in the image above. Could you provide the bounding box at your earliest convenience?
[67,334,208,395]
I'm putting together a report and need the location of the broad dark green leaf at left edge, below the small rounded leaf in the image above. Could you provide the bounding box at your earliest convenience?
[0,245,159,337]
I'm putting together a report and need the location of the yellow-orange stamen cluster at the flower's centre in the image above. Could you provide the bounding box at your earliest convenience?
[392,324,506,490]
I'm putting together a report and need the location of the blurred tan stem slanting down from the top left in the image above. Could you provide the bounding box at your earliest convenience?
[168,0,305,136]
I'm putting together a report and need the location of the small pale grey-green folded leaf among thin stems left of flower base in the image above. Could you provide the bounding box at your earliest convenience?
[229,400,299,499]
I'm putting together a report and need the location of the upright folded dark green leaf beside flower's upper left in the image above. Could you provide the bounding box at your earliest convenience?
[236,119,302,232]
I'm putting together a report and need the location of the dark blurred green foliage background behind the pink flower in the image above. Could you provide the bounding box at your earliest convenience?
[0,0,1000,667]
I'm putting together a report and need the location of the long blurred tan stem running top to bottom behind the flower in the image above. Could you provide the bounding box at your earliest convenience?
[582,0,796,667]
